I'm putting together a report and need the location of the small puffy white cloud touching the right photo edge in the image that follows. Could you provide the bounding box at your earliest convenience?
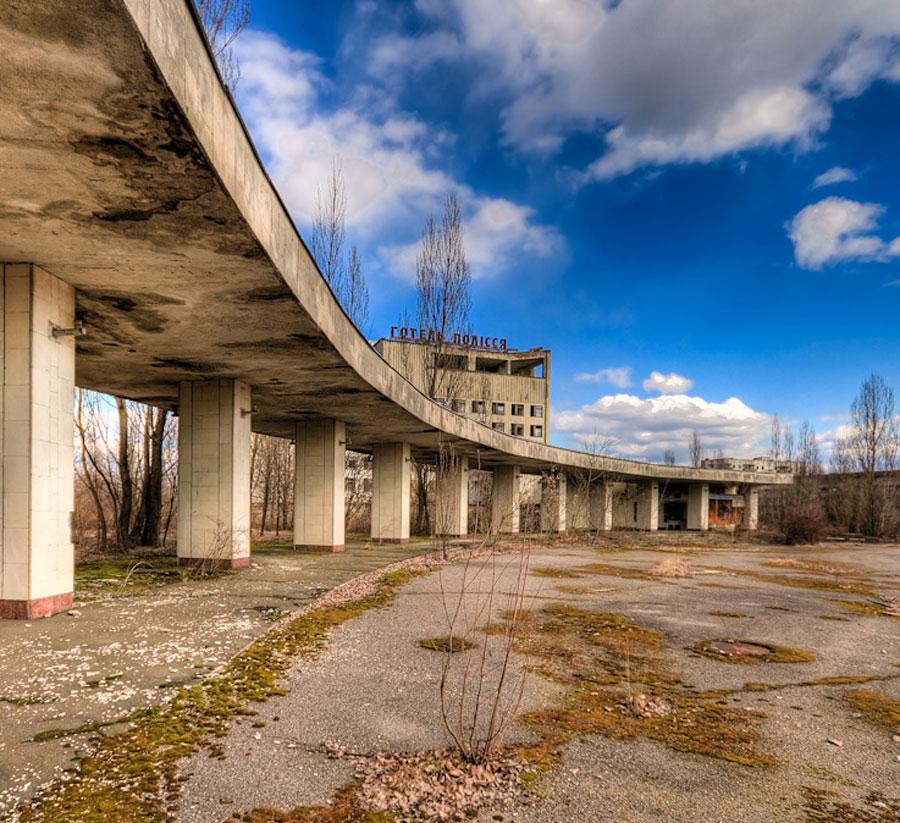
[787,197,900,269]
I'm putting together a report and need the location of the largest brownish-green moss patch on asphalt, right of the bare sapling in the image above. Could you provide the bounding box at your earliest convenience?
[517,604,777,769]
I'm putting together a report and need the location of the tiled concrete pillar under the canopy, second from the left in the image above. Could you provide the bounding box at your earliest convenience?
[178,380,251,569]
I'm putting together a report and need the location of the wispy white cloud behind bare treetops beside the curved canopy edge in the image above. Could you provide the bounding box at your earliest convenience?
[235,31,563,276]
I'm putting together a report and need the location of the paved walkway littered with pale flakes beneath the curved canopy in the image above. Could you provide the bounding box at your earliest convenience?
[0,543,430,817]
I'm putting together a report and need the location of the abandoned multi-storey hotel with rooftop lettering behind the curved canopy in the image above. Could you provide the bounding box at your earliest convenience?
[375,327,550,443]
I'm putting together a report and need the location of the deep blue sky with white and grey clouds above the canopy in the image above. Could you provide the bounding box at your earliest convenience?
[230,0,900,459]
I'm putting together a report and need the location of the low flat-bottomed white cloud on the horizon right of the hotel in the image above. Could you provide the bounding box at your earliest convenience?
[553,394,771,461]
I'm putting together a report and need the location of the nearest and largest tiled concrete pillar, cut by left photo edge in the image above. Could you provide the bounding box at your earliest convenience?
[0,263,75,620]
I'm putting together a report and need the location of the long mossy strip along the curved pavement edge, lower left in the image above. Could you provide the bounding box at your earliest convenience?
[18,571,424,823]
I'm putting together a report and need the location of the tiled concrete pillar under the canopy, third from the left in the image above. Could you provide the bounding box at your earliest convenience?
[294,420,347,552]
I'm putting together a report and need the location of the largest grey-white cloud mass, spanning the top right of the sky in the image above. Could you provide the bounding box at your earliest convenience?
[371,0,900,181]
